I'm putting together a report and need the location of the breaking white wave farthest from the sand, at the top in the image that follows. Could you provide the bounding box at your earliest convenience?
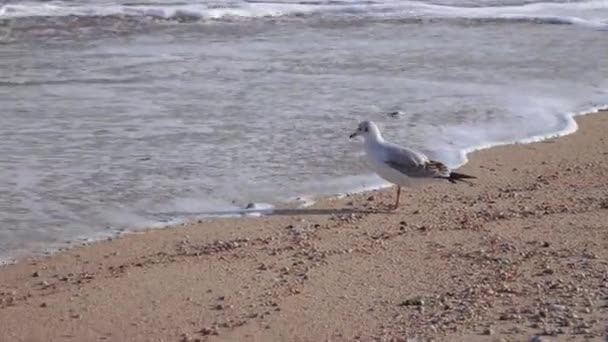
[0,1,608,29]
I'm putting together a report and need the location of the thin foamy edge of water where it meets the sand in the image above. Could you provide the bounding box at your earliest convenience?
[0,105,608,267]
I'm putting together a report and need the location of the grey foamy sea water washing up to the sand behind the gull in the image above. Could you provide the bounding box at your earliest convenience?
[0,0,608,260]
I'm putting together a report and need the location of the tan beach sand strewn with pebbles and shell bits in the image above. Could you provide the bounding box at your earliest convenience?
[0,113,608,341]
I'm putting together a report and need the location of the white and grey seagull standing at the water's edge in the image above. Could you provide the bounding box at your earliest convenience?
[350,121,476,209]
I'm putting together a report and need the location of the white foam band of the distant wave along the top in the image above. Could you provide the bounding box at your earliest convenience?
[0,1,608,29]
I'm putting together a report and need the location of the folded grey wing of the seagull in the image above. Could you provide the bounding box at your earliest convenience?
[385,146,450,178]
